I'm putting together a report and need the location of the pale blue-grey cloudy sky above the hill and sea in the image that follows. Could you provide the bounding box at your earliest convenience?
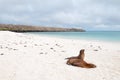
[0,0,120,31]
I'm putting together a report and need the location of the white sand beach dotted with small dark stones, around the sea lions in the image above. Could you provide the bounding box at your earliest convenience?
[0,31,120,80]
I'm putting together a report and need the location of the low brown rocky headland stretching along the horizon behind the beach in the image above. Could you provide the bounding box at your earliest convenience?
[0,24,85,32]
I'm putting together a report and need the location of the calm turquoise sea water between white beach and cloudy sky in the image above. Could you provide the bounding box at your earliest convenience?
[25,31,120,42]
